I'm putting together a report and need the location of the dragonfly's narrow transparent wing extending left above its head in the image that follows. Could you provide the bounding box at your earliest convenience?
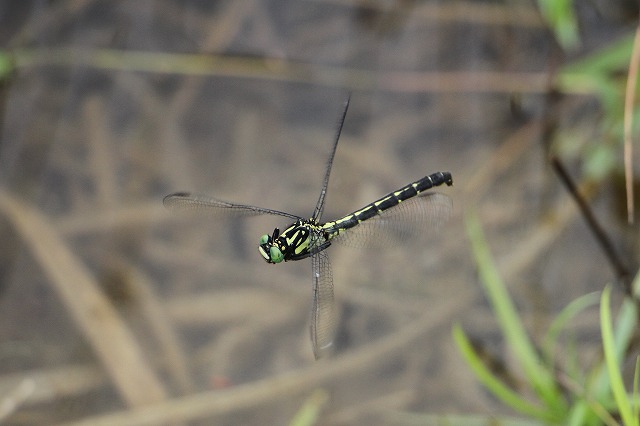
[162,192,299,219]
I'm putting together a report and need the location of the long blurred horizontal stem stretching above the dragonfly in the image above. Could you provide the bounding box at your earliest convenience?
[11,47,556,93]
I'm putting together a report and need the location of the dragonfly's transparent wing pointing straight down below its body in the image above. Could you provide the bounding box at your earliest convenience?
[311,251,336,359]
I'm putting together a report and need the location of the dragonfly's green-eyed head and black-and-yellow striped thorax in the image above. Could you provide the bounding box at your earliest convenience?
[258,219,329,263]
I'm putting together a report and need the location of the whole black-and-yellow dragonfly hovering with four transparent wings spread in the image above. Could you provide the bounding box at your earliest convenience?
[163,97,453,359]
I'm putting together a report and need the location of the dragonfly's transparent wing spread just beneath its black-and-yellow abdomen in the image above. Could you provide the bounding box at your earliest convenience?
[331,192,453,248]
